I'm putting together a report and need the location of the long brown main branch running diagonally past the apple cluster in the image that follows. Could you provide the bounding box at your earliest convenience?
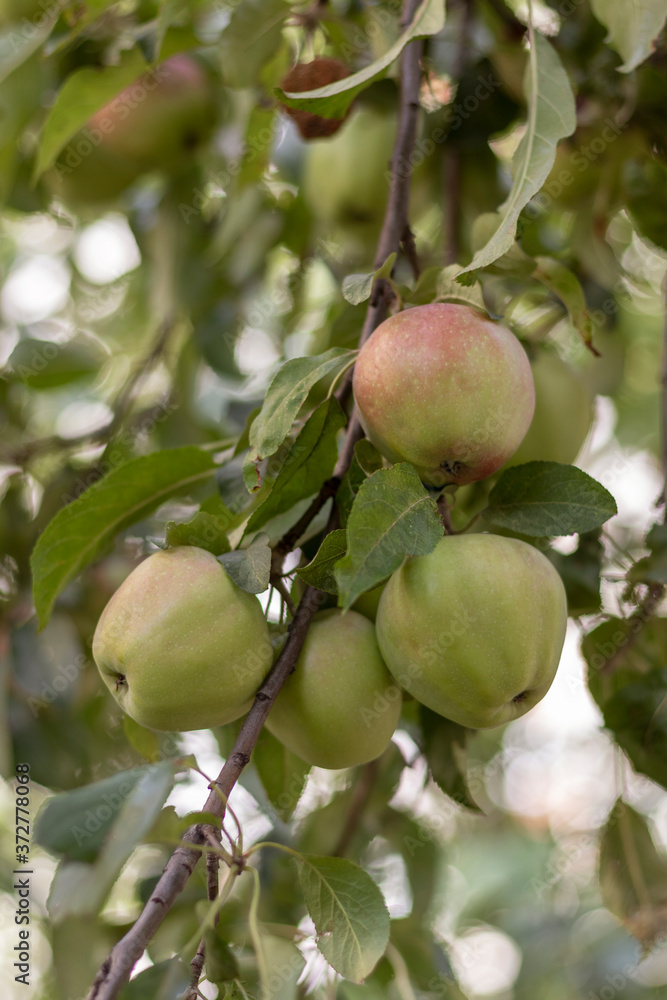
[88,0,422,1000]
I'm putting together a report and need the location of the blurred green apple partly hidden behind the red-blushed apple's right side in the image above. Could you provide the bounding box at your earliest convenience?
[507,350,593,466]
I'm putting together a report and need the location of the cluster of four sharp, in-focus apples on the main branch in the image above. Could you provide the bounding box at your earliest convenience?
[93,304,580,768]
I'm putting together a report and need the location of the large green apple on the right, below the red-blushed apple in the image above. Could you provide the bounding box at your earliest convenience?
[376,534,567,729]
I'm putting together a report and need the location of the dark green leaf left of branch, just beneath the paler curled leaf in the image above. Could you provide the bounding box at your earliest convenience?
[246,398,347,532]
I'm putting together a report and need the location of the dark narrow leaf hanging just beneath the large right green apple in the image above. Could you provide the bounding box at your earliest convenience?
[419,705,480,812]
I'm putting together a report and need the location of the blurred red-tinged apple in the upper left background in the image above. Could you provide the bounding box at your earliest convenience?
[50,55,215,203]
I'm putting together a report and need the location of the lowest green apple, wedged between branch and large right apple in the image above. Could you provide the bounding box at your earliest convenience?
[266,609,401,768]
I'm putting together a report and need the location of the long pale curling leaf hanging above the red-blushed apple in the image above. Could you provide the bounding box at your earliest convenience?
[460,32,577,274]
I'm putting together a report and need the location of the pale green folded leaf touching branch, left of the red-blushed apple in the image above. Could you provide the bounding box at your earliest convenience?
[250,347,356,459]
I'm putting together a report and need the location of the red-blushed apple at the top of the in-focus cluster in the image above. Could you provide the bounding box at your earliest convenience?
[354,303,535,486]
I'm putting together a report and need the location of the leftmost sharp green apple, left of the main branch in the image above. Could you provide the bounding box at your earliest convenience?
[93,546,273,731]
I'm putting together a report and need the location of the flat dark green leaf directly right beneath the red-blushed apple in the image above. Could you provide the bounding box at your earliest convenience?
[482,462,617,538]
